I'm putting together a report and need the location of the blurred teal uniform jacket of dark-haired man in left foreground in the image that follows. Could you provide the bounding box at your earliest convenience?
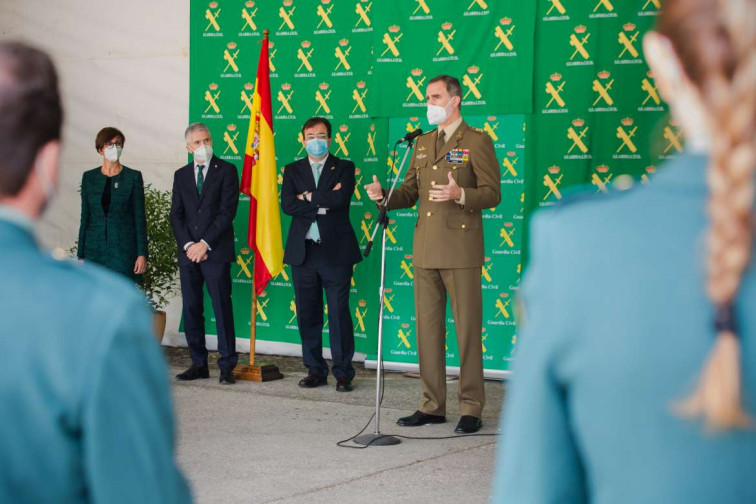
[0,217,191,504]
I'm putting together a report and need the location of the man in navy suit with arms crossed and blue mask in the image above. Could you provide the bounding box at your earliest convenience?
[281,117,362,392]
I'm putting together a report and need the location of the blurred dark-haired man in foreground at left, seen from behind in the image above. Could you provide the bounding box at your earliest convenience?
[0,42,191,503]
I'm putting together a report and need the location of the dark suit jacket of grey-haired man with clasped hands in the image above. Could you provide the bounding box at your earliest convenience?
[171,156,239,266]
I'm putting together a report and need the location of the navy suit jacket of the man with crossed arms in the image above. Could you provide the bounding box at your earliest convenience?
[281,154,362,266]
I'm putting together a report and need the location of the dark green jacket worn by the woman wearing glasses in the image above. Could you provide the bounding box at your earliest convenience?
[78,166,147,282]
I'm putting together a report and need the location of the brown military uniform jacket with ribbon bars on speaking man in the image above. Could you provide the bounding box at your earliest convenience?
[388,121,501,269]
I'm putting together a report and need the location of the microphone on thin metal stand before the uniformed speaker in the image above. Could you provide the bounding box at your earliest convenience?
[354,138,415,446]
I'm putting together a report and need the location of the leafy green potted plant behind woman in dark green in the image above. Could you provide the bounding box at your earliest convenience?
[142,184,178,340]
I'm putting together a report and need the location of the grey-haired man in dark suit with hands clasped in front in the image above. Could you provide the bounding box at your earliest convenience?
[171,123,239,384]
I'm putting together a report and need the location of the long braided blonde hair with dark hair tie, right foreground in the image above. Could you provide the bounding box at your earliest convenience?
[659,0,756,429]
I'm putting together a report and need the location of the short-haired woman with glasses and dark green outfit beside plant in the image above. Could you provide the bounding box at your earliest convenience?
[78,127,147,283]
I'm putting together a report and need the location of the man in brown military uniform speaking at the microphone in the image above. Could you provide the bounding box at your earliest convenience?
[365,75,501,434]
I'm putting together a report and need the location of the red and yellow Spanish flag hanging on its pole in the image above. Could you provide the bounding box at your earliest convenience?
[241,30,283,295]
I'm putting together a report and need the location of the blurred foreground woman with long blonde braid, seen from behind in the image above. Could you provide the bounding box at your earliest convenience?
[493,0,756,504]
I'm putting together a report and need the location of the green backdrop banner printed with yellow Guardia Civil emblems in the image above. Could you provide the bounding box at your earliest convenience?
[189,0,682,375]
